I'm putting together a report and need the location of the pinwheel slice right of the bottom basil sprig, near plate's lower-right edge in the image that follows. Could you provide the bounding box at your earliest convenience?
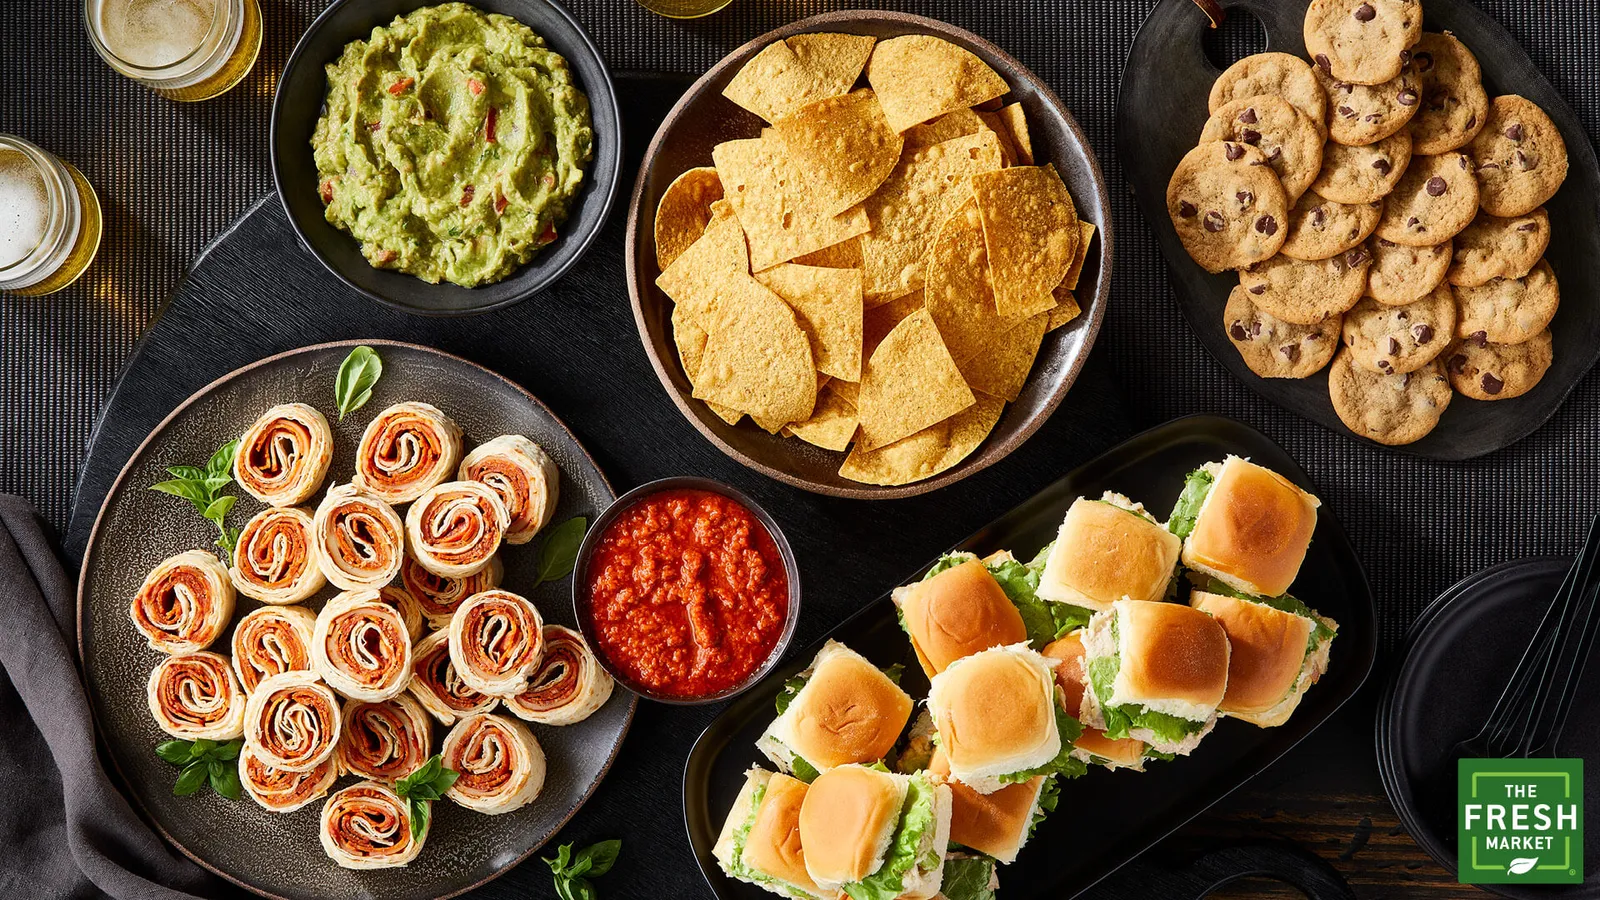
[442,714,546,815]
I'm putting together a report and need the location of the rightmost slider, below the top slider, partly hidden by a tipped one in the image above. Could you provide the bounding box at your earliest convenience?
[1189,581,1339,729]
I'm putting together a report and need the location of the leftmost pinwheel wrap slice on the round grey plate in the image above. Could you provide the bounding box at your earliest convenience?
[128,549,234,655]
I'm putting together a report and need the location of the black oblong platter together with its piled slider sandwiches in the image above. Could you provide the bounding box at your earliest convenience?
[683,416,1376,900]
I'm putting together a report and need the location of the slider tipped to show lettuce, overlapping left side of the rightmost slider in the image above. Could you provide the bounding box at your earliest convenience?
[1082,601,1229,756]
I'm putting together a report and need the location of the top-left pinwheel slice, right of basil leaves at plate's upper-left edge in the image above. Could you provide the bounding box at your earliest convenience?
[234,404,333,506]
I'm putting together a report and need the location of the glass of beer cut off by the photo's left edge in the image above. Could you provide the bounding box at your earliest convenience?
[0,135,101,296]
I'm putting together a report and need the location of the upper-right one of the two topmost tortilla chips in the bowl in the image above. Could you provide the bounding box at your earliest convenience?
[867,34,1011,131]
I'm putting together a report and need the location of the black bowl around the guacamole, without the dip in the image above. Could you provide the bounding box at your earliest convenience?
[269,0,622,315]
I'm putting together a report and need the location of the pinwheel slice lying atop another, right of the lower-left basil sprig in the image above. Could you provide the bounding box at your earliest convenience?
[245,671,342,772]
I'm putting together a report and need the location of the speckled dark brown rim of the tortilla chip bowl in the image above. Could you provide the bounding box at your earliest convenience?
[622,10,1114,500]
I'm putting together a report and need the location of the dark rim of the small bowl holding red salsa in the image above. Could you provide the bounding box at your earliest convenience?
[573,476,800,706]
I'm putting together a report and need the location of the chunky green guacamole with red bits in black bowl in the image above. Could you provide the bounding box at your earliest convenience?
[310,3,594,287]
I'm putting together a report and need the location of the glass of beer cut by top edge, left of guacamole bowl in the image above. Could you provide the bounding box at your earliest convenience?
[83,0,261,101]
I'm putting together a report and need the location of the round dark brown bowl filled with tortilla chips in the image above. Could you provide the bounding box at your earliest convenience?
[627,11,1112,498]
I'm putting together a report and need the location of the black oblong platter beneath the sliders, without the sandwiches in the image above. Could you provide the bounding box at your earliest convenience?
[683,416,1378,900]
